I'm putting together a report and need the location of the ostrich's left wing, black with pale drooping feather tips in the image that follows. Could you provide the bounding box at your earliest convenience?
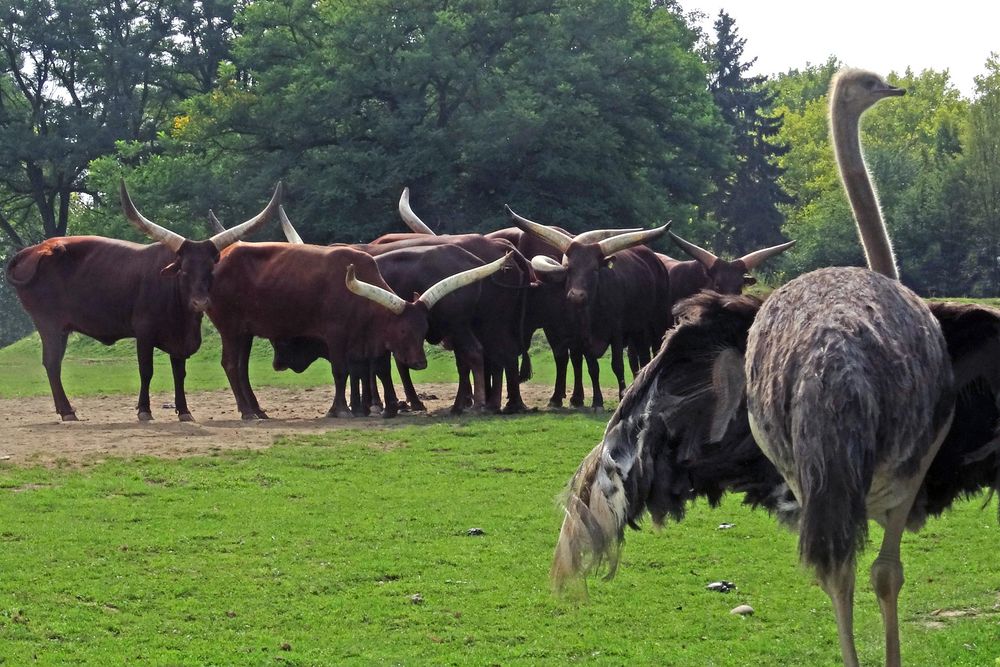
[552,292,787,587]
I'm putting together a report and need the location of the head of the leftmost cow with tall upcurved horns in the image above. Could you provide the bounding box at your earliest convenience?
[119,179,282,313]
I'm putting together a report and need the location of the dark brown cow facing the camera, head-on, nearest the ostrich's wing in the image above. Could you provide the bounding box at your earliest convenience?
[506,206,670,409]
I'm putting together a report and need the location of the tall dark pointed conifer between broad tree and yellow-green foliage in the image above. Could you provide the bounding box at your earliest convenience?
[708,11,792,254]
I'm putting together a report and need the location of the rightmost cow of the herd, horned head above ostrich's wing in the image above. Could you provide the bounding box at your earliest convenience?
[659,232,795,305]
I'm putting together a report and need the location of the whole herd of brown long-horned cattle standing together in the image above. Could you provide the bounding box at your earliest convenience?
[6,182,794,421]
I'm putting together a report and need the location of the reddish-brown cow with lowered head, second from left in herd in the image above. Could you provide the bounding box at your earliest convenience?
[208,243,505,419]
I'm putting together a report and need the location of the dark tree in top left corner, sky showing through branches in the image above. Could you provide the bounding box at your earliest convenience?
[0,0,233,246]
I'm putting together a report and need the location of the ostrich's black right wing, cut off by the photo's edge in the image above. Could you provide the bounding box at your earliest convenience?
[909,303,1000,528]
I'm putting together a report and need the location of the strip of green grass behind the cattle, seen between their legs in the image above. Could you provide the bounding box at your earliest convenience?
[0,322,620,401]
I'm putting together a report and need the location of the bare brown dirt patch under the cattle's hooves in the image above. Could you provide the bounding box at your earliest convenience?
[0,383,614,465]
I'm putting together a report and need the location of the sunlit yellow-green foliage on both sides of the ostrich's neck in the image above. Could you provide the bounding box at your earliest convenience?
[773,61,1000,295]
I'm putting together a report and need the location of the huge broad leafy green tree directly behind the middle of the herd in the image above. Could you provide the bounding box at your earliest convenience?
[150,0,725,242]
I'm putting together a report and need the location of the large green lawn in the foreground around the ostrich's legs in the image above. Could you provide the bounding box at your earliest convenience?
[0,414,1000,666]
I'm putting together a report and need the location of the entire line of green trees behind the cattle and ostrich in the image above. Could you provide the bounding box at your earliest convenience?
[0,0,1000,343]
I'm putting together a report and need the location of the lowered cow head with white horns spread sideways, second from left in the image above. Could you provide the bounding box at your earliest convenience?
[345,253,510,370]
